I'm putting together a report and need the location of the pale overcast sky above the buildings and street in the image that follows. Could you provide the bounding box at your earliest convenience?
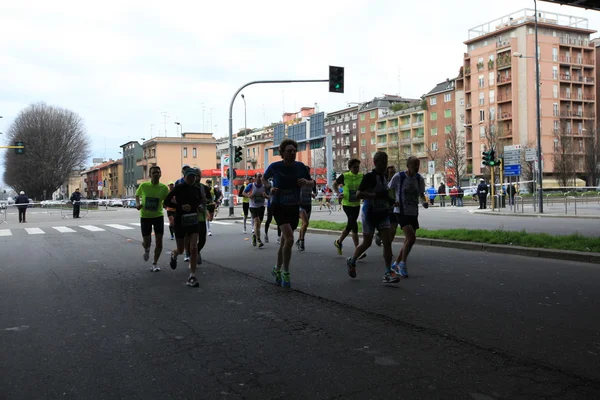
[0,0,600,183]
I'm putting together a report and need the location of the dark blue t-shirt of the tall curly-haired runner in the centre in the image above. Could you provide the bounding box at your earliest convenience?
[264,161,311,206]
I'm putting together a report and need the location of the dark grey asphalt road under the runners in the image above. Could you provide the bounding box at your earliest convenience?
[0,210,600,399]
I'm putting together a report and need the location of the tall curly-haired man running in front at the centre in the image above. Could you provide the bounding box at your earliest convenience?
[263,139,314,288]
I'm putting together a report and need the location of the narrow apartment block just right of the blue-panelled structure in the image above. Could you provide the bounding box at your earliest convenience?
[325,106,358,173]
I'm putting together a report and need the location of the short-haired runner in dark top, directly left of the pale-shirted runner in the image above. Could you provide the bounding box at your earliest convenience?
[346,151,400,283]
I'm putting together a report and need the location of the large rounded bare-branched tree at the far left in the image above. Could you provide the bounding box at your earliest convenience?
[4,103,90,198]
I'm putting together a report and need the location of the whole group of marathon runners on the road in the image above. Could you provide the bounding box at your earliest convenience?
[136,139,428,287]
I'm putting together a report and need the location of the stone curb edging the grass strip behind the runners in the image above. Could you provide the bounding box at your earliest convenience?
[236,220,600,265]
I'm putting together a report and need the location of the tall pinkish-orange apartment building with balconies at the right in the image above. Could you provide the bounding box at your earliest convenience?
[463,9,597,181]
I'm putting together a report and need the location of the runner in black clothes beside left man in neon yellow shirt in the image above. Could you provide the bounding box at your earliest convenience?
[165,168,206,287]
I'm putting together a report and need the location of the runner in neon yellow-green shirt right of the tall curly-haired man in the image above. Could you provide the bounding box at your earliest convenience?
[333,158,367,259]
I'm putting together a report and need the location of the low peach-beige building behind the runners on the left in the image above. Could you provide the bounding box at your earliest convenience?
[137,132,217,184]
